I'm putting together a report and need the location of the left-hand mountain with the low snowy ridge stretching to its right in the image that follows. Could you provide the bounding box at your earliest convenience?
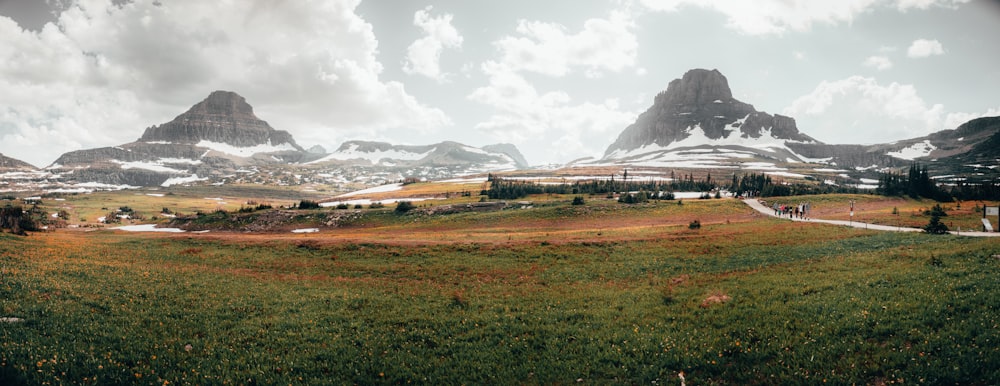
[35,91,528,186]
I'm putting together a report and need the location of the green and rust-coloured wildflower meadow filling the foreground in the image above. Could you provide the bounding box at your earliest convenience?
[0,191,1000,385]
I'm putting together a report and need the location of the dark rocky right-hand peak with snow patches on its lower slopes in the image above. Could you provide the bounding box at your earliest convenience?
[605,69,815,156]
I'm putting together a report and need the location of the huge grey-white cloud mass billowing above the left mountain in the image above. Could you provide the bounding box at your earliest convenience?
[0,0,450,164]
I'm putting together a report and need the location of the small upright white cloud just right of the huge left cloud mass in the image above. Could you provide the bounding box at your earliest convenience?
[403,6,463,81]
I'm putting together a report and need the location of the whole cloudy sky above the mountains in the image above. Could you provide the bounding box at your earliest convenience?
[0,0,1000,166]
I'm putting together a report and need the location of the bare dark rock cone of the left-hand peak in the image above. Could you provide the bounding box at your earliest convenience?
[139,91,304,151]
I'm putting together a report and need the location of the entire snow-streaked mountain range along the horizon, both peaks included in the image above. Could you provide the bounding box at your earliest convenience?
[0,69,1000,193]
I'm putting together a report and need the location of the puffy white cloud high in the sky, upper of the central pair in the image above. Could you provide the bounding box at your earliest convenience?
[494,12,639,77]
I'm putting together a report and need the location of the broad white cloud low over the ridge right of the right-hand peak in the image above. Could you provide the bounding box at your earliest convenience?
[782,76,998,143]
